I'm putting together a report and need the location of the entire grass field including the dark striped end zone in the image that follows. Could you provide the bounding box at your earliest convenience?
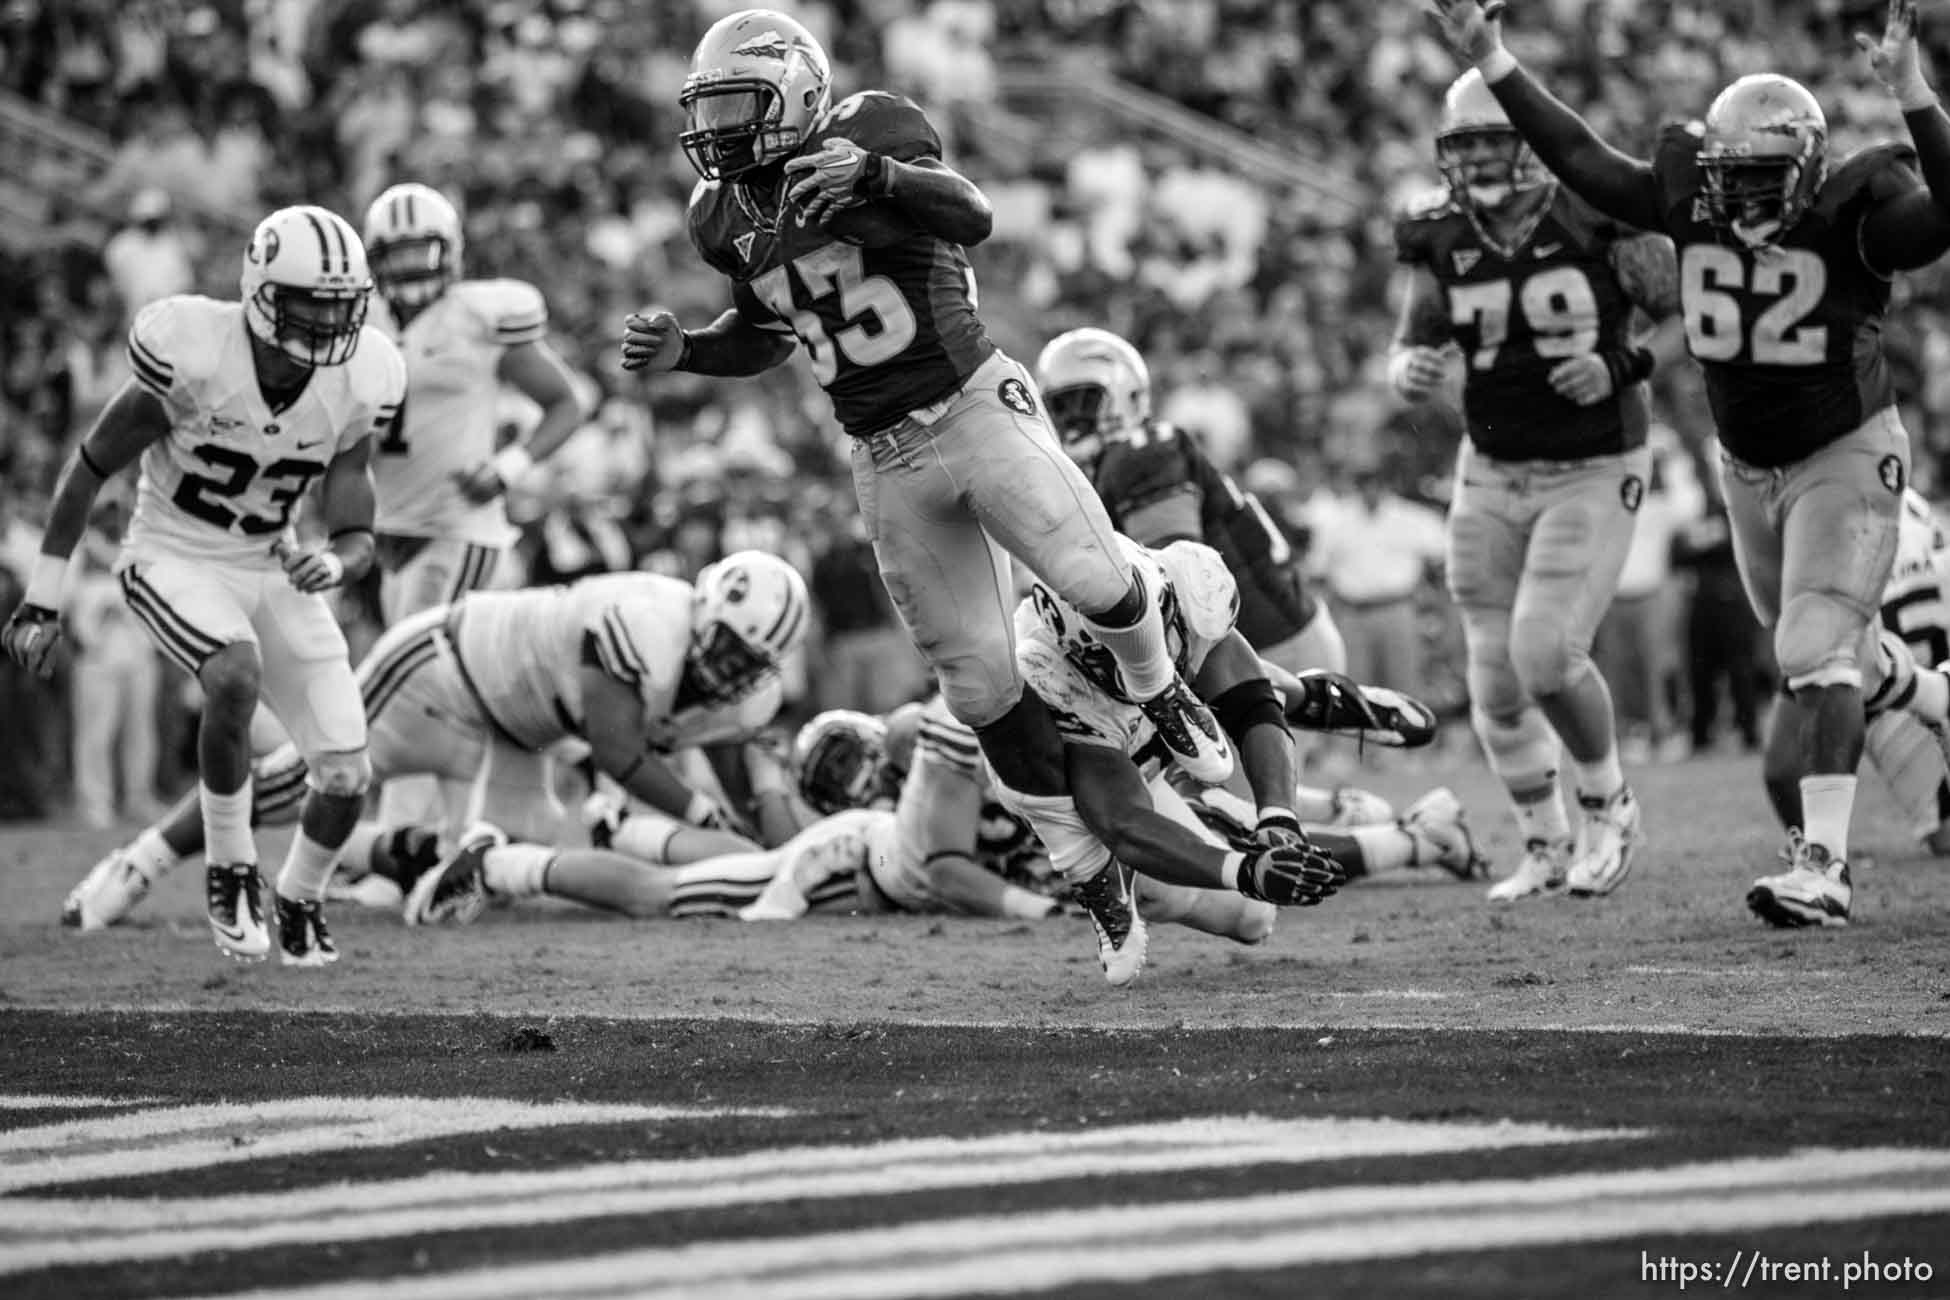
[0,760,1950,1298]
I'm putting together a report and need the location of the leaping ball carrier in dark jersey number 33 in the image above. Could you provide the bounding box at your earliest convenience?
[622,10,1232,935]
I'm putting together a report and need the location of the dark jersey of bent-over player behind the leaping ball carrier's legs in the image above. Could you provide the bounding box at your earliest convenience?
[1090,421,1316,649]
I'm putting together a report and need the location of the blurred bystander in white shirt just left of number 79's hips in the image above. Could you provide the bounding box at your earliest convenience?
[1308,464,1445,694]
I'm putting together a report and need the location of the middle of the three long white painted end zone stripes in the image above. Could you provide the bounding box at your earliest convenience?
[0,1117,1642,1273]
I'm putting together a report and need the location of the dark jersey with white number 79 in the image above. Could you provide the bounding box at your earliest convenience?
[1394,187,1648,460]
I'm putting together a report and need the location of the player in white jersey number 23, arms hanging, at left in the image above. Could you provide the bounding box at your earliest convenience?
[6,207,406,965]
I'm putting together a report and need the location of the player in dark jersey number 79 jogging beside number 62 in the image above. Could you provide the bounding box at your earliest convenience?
[1388,70,1685,902]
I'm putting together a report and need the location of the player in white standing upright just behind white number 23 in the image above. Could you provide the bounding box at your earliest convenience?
[365,183,589,624]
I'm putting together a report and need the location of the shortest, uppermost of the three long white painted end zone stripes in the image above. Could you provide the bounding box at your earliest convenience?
[0,1097,792,1193]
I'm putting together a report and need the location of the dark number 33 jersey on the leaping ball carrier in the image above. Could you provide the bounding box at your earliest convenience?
[690,90,995,437]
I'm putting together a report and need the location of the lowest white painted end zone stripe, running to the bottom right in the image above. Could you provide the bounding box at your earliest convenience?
[190,1148,1950,1300]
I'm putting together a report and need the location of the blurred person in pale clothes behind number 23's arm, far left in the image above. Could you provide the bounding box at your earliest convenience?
[66,479,162,828]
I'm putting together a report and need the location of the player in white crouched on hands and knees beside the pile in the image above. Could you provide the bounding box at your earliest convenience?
[68,552,809,930]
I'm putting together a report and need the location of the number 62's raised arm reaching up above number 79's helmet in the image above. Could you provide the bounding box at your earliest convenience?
[1433,0,1663,230]
